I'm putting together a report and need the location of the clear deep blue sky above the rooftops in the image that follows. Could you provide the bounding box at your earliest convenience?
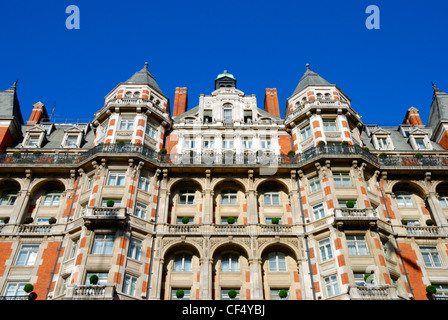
[0,0,448,125]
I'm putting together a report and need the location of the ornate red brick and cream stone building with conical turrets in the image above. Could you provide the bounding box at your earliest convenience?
[0,64,448,300]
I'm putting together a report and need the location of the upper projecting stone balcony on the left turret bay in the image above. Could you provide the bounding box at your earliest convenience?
[83,207,126,229]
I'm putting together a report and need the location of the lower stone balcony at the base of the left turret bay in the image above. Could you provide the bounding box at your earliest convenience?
[63,285,115,300]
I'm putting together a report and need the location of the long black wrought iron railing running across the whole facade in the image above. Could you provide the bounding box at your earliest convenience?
[0,143,448,167]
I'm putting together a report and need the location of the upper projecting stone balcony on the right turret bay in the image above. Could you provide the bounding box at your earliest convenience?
[334,208,378,227]
